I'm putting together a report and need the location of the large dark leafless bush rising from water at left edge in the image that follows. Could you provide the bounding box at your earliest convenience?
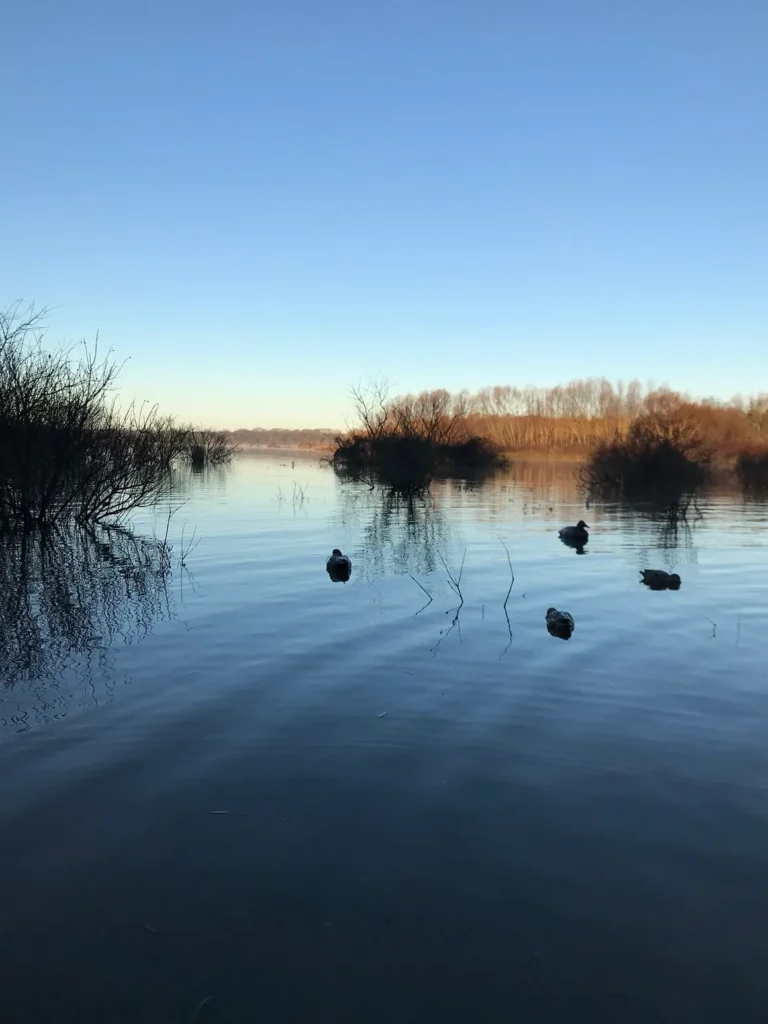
[0,303,236,527]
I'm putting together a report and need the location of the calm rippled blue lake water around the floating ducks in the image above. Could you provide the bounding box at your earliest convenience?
[0,453,768,1024]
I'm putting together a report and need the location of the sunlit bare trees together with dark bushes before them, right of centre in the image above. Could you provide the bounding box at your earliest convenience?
[333,379,768,495]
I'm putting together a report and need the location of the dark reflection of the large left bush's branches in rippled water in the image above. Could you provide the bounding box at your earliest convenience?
[0,527,174,730]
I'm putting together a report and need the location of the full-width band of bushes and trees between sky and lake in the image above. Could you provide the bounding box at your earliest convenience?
[0,303,768,526]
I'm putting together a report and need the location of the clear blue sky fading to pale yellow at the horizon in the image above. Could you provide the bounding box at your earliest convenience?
[0,0,768,428]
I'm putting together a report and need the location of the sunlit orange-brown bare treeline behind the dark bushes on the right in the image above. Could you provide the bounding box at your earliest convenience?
[353,379,768,457]
